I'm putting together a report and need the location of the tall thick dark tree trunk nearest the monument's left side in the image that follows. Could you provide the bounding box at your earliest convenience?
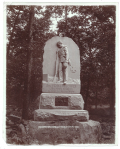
[22,6,34,120]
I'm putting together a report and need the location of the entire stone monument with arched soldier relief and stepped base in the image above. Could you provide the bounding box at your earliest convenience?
[31,36,101,144]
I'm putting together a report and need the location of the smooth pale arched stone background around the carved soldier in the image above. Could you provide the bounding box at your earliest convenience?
[43,36,80,79]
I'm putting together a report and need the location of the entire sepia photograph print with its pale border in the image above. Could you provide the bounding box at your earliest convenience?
[4,2,118,146]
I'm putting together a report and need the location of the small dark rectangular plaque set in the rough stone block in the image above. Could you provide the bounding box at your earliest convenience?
[55,97,68,106]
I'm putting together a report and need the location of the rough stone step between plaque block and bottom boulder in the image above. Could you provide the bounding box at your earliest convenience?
[34,109,89,121]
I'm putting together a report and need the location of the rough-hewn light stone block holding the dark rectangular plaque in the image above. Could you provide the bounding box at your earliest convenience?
[39,93,84,110]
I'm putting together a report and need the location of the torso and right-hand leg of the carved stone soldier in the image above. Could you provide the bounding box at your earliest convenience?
[58,46,68,83]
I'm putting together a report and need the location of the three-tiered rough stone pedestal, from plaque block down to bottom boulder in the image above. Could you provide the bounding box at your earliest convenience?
[33,93,101,144]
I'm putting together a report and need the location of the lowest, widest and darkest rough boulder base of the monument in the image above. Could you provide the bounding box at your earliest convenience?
[28,120,101,144]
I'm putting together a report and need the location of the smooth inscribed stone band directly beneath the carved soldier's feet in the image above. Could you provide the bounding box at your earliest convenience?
[42,82,80,94]
